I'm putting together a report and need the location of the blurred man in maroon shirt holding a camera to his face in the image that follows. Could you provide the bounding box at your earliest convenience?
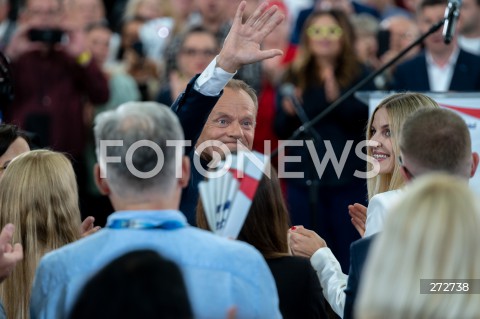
[5,0,109,218]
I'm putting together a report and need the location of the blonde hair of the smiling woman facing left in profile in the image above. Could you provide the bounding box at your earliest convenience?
[367,93,440,199]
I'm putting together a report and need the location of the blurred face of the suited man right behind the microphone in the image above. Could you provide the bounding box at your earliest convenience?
[419,4,450,54]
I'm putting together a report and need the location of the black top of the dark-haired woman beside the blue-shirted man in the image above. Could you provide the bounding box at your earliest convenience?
[266,256,327,319]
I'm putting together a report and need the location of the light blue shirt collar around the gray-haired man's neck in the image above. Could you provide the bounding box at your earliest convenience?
[107,210,188,229]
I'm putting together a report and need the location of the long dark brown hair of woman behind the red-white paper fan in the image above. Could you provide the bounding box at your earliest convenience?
[197,167,290,258]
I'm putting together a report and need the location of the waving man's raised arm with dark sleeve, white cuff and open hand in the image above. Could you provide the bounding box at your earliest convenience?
[172,1,285,153]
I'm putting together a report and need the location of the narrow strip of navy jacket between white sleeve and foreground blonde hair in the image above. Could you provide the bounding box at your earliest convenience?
[343,235,376,319]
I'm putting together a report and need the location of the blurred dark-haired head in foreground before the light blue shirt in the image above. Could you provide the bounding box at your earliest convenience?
[70,250,193,319]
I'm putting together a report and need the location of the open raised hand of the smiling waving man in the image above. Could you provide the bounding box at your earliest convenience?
[217,1,285,73]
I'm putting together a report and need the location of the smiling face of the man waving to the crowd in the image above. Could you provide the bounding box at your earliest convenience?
[197,87,257,155]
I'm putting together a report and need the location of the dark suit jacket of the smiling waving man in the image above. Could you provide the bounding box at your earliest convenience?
[171,75,223,226]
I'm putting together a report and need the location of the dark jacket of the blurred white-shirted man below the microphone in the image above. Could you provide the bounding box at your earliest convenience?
[391,50,480,92]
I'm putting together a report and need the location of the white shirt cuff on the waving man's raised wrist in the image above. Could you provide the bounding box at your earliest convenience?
[193,56,237,96]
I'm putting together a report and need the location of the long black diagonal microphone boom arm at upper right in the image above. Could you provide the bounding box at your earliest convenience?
[270,18,446,158]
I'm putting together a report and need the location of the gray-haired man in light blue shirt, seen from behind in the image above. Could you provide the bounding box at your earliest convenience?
[30,102,281,319]
